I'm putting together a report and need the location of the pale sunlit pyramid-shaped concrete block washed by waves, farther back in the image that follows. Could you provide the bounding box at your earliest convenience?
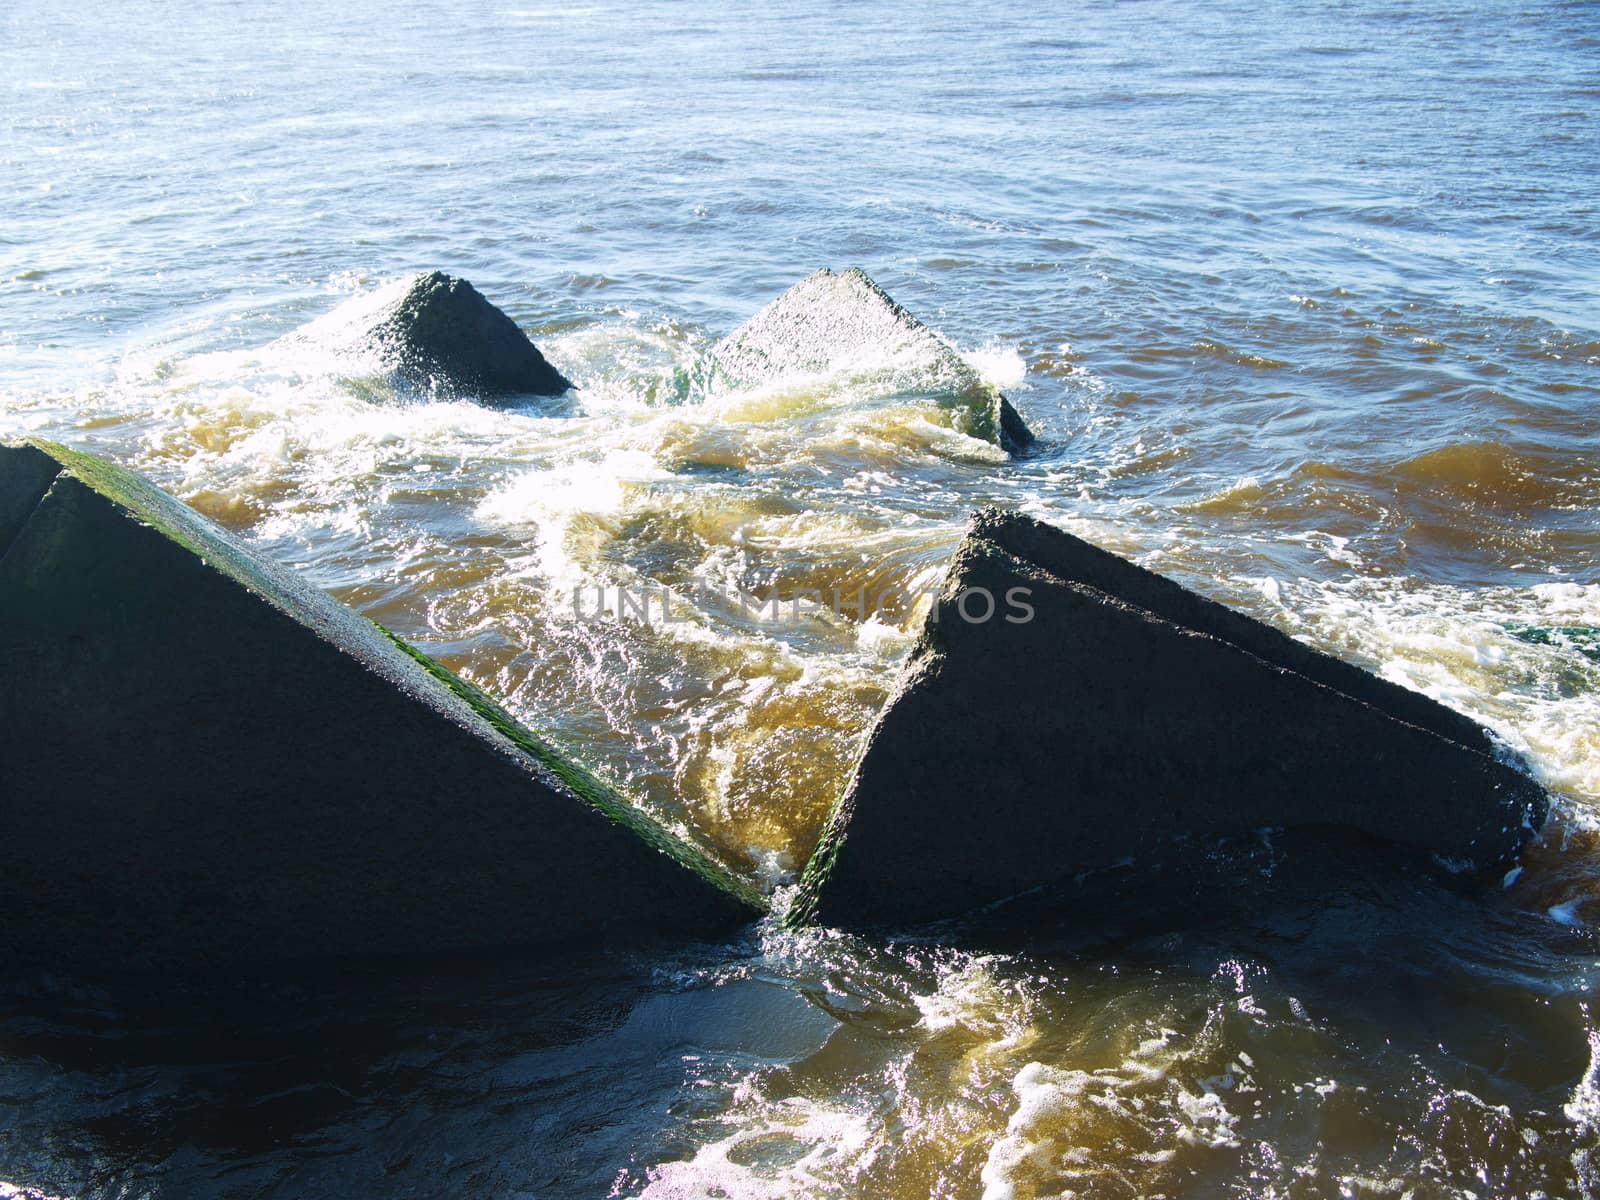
[709,269,1034,453]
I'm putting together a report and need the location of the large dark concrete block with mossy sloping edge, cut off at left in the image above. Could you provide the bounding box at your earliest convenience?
[0,443,760,968]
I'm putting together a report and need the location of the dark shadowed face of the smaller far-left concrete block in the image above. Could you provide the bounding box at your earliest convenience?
[368,270,571,398]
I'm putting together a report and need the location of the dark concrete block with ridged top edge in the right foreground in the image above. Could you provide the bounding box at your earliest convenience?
[805,510,1547,925]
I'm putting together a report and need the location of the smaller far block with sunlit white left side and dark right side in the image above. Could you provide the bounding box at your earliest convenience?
[291,270,571,402]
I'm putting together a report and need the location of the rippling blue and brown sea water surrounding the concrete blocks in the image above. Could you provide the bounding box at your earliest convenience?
[0,0,1600,1200]
